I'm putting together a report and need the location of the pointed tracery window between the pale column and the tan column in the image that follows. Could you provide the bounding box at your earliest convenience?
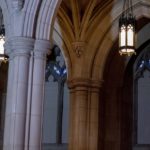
[43,45,69,150]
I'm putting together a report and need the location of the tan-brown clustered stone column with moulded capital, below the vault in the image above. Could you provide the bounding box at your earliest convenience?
[69,78,101,150]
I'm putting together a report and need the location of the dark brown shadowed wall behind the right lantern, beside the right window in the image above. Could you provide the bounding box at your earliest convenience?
[100,17,150,150]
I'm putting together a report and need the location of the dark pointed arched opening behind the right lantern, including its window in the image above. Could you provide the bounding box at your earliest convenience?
[103,18,150,150]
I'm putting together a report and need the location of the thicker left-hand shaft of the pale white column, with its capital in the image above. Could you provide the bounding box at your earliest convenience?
[3,37,34,150]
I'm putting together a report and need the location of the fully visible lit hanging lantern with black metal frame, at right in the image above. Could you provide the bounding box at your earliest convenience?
[119,0,136,56]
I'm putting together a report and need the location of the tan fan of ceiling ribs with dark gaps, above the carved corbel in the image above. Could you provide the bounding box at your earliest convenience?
[57,0,116,41]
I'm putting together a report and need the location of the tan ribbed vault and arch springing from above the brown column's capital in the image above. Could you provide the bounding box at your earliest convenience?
[55,0,150,80]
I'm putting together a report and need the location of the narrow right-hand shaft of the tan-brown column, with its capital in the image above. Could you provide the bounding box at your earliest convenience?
[88,81,103,150]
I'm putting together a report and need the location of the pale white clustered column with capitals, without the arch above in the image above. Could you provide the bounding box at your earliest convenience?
[3,37,50,150]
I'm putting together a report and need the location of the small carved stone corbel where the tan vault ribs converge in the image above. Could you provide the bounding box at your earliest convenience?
[72,42,86,57]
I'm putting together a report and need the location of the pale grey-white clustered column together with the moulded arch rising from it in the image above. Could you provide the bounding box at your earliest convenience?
[1,0,61,150]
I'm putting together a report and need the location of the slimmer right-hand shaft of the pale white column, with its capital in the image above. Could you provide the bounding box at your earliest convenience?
[29,40,50,150]
